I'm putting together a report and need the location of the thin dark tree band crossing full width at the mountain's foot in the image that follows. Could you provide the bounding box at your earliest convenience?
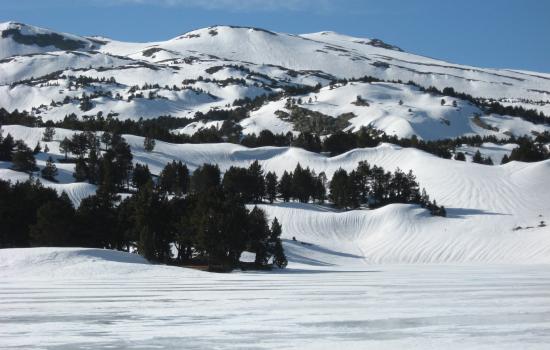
[0,108,550,162]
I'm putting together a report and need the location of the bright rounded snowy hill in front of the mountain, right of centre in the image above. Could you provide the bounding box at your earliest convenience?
[240,82,550,140]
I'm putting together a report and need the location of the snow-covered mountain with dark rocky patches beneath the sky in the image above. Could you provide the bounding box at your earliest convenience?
[0,22,550,139]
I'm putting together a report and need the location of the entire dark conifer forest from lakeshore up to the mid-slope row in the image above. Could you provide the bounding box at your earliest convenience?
[0,129,446,271]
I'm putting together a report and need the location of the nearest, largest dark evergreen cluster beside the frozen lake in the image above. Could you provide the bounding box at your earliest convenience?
[0,162,287,271]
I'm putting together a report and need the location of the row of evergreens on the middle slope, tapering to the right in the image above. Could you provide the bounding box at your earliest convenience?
[216,161,446,216]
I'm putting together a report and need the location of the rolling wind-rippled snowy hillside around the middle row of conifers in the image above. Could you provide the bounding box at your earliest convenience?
[4,126,550,265]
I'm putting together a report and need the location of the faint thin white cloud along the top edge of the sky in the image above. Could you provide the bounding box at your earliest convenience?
[93,0,333,12]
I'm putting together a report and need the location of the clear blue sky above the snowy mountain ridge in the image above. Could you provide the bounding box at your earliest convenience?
[4,0,550,72]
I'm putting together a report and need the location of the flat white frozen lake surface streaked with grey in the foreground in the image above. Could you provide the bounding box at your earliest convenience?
[0,250,550,350]
